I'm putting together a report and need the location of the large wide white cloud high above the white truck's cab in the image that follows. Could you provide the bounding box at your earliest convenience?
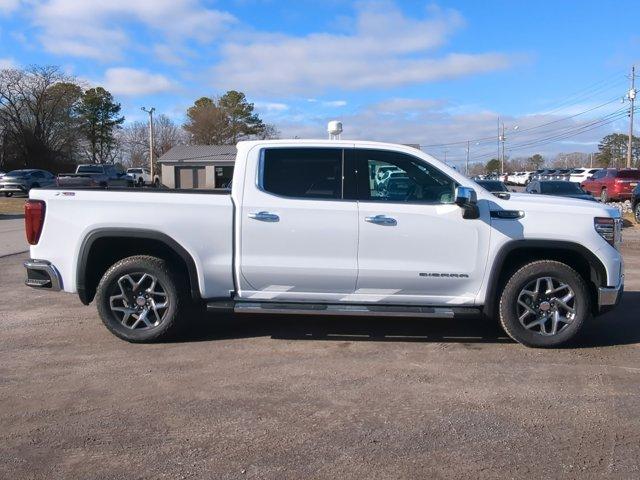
[213,2,512,95]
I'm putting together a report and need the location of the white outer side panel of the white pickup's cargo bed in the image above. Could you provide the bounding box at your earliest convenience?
[30,187,234,298]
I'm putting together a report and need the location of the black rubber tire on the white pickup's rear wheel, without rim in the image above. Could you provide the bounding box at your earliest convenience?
[95,255,187,343]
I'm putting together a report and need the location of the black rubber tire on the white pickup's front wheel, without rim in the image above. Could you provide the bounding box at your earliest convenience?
[499,260,591,348]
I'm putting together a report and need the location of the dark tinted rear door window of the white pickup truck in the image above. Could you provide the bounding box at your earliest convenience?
[261,148,342,199]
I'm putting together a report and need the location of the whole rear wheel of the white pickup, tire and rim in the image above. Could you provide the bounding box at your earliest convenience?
[96,255,185,342]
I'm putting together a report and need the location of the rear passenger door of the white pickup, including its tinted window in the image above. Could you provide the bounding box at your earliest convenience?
[239,147,358,301]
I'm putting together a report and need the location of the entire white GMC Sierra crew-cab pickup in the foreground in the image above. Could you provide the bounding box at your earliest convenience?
[25,140,624,347]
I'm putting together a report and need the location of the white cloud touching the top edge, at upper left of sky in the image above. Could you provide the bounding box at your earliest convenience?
[31,0,235,60]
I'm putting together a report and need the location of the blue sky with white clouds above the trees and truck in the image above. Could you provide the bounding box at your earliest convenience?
[0,0,640,165]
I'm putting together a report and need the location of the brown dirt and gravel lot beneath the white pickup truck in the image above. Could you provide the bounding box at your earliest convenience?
[0,228,640,479]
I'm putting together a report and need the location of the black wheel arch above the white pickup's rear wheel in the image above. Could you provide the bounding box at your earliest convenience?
[76,228,202,305]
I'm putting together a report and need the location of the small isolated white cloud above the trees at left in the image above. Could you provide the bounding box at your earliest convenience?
[100,67,176,96]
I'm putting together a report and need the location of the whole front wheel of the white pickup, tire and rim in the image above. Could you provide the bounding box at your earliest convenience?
[500,260,591,348]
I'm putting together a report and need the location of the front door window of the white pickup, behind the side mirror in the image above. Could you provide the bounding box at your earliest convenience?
[357,150,456,203]
